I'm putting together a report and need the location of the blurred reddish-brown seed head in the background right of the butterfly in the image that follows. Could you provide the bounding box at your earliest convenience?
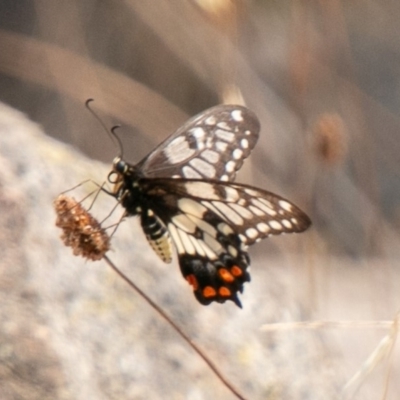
[313,114,347,165]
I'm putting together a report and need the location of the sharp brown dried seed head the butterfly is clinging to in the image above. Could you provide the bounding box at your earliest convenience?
[54,195,110,261]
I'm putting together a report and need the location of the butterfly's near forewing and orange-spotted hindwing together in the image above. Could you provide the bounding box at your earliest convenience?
[141,178,310,305]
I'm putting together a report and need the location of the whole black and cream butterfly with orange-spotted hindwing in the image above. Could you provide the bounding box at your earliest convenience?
[108,105,311,307]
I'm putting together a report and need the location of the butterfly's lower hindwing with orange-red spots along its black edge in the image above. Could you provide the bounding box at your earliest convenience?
[136,179,250,306]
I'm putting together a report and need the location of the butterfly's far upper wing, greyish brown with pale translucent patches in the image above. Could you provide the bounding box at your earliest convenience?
[137,105,260,181]
